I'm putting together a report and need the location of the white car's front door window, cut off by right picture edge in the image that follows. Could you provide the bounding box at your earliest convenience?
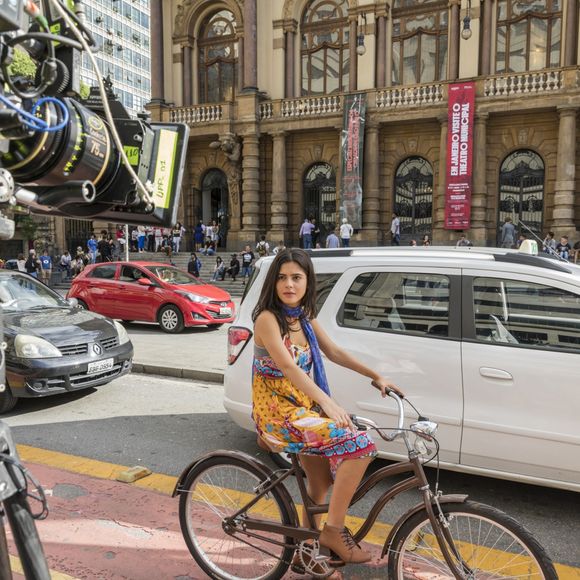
[473,278,580,351]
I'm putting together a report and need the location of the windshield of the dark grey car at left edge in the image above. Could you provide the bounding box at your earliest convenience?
[0,274,68,312]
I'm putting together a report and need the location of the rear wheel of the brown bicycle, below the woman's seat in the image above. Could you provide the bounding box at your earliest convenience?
[179,457,296,580]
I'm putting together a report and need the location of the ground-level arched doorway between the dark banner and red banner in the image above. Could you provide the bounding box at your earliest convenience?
[395,157,433,241]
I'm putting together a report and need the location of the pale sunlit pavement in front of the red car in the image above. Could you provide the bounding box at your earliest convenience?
[126,298,240,383]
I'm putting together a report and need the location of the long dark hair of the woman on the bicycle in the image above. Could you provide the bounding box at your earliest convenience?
[252,248,316,336]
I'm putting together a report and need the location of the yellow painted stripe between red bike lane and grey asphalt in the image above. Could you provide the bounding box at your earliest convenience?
[17,445,580,580]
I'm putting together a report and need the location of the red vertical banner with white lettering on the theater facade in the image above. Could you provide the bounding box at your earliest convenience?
[445,82,474,230]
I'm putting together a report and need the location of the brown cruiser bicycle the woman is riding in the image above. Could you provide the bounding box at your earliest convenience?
[173,392,558,580]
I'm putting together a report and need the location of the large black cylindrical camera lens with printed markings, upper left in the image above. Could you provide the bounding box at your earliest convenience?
[2,99,119,191]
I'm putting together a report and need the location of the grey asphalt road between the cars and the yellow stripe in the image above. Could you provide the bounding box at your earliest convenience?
[2,375,580,567]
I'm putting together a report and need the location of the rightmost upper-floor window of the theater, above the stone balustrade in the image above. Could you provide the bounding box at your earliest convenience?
[495,0,562,73]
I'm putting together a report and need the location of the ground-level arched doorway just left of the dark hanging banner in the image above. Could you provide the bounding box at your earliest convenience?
[303,163,338,234]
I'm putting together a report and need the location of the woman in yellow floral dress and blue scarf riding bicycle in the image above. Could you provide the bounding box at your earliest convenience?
[252,249,400,563]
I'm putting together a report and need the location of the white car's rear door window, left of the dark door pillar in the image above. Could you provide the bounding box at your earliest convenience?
[338,272,449,336]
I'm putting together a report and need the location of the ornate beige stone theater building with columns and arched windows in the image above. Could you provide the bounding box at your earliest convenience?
[146,0,580,249]
